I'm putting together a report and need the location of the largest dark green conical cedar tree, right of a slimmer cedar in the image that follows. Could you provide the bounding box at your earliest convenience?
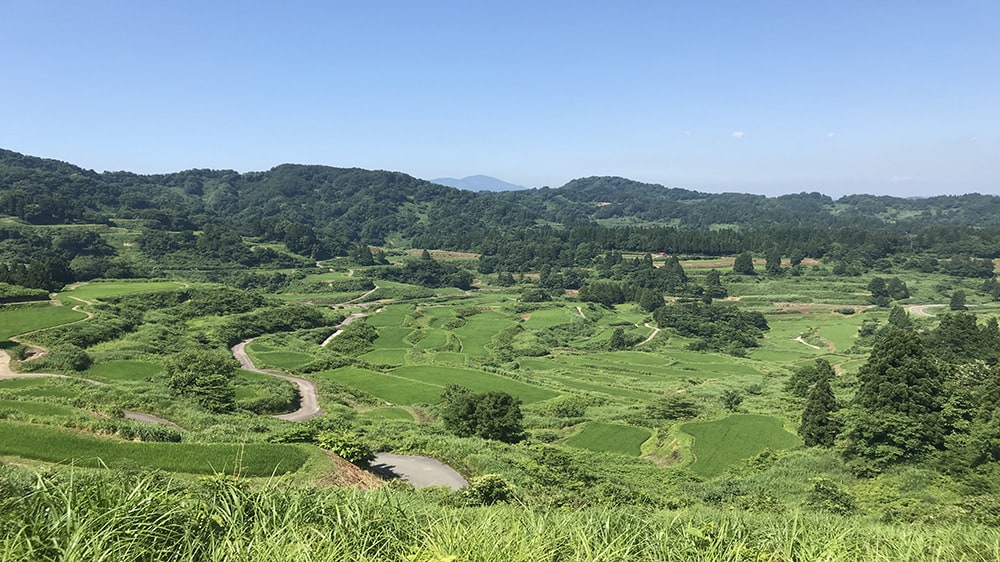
[844,330,945,469]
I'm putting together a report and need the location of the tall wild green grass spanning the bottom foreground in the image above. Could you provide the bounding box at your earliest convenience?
[0,468,1000,562]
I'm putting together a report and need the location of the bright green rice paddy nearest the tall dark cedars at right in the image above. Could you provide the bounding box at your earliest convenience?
[681,414,802,476]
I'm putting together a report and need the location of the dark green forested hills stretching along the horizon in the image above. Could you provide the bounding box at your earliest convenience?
[0,150,1000,238]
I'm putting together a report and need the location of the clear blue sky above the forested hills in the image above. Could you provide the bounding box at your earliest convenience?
[0,0,1000,196]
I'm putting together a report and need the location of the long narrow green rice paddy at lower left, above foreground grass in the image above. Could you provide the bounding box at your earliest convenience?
[0,422,308,476]
